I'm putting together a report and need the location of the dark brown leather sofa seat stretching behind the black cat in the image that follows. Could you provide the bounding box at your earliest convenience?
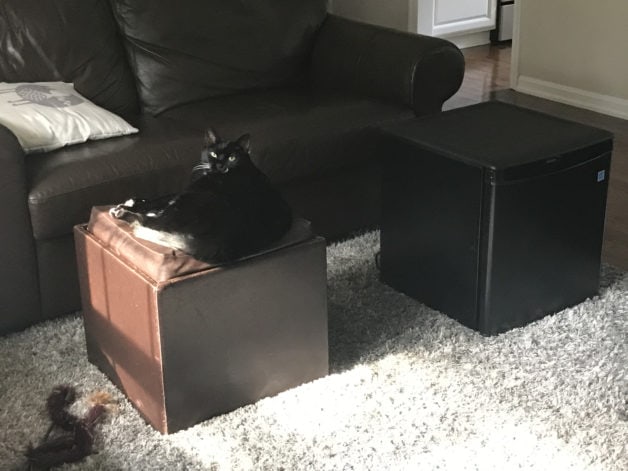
[27,90,412,240]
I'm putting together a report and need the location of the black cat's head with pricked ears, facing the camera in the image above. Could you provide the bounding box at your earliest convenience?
[194,128,251,173]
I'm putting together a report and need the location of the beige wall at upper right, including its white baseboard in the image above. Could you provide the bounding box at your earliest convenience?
[512,0,628,118]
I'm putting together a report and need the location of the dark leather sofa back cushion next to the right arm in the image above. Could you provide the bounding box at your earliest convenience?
[112,0,327,114]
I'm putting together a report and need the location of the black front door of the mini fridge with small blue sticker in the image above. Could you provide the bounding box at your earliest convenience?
[479,152,611,333]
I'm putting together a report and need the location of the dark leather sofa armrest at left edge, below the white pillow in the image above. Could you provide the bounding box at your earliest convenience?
[0,125,43,335]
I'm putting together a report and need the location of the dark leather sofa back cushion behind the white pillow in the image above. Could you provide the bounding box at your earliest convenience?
[0,0,138,116]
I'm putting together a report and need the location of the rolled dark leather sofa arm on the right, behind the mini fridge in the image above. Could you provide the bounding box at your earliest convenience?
[310,15,464,116]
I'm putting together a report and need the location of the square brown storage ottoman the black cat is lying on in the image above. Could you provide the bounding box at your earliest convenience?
[74,207,328,433]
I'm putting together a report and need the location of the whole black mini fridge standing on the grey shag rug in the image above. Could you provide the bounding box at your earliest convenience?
[380,102,612,334]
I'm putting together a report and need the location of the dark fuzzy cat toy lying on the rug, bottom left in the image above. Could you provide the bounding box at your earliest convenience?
[24,385,113,471]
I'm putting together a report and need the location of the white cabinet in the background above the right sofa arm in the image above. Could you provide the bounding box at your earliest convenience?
[408,0,497,44]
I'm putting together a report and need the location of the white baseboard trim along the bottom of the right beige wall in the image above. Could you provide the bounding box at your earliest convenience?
[513,76,628,119]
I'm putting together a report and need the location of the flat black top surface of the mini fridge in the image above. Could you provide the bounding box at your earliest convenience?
[381,101,613,171]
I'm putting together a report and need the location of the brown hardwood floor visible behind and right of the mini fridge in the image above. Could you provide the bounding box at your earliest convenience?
[443,46,628,270]
